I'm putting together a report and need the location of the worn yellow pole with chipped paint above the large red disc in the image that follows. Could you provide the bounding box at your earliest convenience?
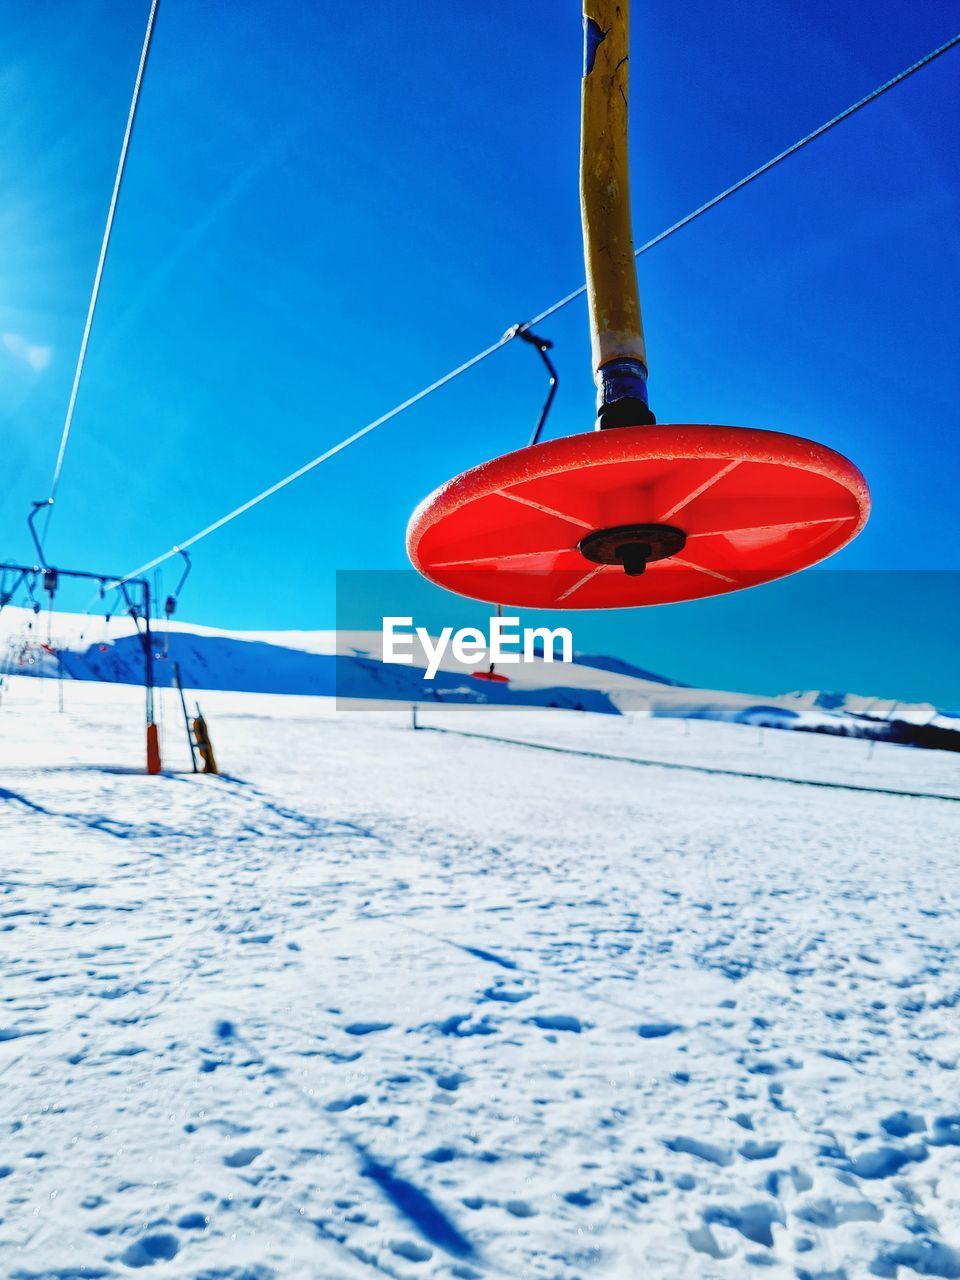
[580,0,655,428]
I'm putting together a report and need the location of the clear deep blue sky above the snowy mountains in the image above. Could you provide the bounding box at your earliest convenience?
[0,0,960,703]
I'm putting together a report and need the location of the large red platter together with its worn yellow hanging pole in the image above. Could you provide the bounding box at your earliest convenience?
[407,0,870,609]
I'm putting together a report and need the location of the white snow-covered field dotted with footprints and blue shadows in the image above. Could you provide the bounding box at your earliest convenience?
[0,677,960,1280]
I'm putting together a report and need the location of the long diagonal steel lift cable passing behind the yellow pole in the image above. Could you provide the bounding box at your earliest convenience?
[110,33,960,581]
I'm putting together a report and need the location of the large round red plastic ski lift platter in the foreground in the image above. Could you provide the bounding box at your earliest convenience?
[407,425,870,609]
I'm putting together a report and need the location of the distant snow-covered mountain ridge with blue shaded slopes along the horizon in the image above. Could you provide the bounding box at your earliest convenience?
[0,608,960,750]
